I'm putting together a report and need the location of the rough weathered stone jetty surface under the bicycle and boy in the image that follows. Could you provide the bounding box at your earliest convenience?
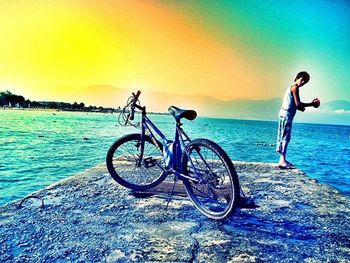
[0,162,350,262]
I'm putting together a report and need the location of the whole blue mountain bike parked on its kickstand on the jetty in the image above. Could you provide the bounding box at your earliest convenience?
[106,91,240,220]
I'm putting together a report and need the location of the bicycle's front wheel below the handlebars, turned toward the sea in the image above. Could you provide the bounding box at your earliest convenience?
[106,134,167,190]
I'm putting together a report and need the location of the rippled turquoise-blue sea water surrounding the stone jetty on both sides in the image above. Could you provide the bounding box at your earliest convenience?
[0,110,350,205]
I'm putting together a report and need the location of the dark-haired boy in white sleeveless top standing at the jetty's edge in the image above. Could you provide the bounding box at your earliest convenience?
[276,71,320,169]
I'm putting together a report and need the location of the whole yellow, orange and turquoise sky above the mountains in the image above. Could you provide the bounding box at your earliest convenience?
[0,0,350,111]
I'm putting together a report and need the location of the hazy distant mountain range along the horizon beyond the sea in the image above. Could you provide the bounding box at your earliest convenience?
[65,85,350,123]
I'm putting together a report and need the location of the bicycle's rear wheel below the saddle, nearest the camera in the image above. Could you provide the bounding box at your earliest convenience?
[182,139,240,220]
